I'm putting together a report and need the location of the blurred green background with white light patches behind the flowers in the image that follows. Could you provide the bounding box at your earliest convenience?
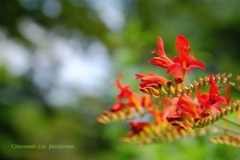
[0,0,240,160]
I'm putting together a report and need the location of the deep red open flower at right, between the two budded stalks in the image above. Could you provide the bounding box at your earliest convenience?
[198,77,227,112]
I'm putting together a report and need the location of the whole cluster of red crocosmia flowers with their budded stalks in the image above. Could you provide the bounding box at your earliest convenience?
[97,35,240,147]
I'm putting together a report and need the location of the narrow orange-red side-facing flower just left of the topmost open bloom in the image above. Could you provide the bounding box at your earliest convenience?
[149,37,180,77]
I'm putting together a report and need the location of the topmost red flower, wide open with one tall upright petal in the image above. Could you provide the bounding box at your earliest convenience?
[167,35,206,77]
